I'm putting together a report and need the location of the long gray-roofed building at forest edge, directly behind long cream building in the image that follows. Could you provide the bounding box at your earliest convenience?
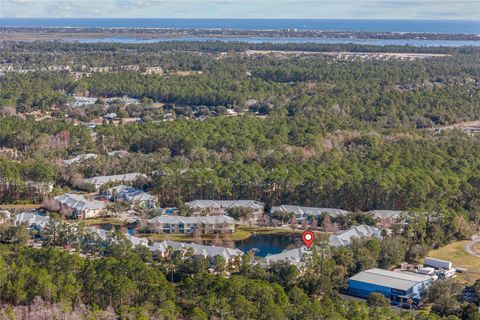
[185,200,264,221]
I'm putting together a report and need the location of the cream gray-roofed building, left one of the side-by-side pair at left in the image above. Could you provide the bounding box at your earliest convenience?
[54,193,106,219]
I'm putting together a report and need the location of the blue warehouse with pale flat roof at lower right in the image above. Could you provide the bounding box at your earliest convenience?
[348,268,433,305]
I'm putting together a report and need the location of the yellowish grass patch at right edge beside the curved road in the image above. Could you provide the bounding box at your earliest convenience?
[428,240,480,282]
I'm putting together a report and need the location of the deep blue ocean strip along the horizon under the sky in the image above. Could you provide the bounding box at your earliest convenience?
[0,18,480,34]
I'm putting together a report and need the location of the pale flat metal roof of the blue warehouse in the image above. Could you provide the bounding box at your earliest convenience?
[350,268,432,291]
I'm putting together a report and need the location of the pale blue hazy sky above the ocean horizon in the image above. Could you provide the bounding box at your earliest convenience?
[0,0,480,20]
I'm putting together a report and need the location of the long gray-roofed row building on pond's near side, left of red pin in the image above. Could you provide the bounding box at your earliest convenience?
[149,241,243,263]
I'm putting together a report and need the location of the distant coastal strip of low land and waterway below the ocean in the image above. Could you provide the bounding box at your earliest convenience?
[0,26,480,45]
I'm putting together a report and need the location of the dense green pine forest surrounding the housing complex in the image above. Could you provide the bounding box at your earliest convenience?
[0,42,480,320]
